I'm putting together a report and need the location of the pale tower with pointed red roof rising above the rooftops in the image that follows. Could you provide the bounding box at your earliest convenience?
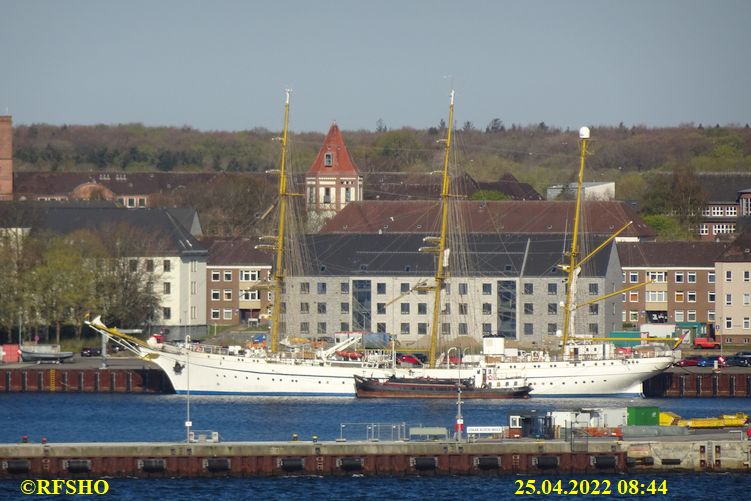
[305,122,362,232]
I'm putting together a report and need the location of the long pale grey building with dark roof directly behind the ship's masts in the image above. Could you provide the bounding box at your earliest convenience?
[283,233,622,347]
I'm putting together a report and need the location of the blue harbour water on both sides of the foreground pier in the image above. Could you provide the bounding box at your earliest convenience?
[0,393,751,500]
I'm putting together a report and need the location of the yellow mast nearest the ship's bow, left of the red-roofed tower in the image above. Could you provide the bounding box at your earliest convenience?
[256,89,296,353]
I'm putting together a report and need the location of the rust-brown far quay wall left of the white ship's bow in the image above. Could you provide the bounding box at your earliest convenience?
[0,366,174,393]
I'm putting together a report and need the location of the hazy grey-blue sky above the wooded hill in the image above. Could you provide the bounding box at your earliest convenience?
[0,0,751,132]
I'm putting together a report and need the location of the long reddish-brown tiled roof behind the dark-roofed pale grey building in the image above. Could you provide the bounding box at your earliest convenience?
[320,201,656,239]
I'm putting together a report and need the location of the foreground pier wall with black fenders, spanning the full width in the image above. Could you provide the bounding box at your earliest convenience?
[0,438,751,479]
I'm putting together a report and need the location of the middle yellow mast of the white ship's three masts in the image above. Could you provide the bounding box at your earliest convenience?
[420,89,454,367]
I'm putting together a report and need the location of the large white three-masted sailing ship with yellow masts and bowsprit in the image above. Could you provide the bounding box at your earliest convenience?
[87,91,674,397]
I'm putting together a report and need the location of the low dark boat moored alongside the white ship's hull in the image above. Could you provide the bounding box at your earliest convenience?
[355,375,531,399]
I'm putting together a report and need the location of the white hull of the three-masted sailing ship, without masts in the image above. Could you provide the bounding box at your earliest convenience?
[142,349,673,397]
